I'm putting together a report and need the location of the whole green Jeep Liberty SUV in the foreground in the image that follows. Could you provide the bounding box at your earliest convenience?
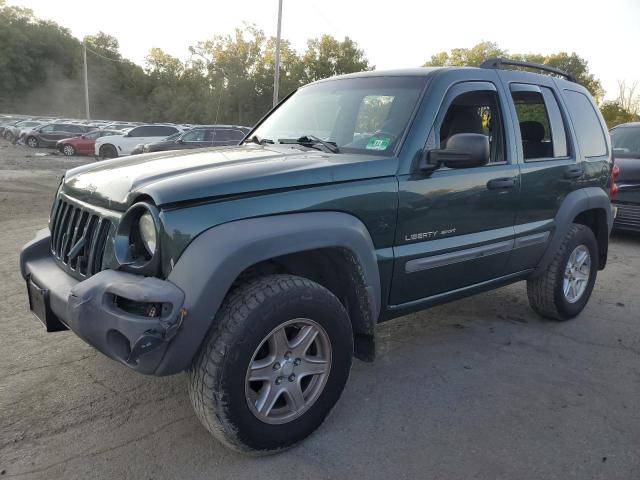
[20,59,613,453]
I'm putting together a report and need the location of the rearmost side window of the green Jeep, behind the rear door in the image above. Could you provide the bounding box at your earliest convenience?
[564,90,607,157]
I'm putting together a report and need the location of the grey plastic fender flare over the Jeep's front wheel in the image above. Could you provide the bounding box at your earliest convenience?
[155,212,381,375]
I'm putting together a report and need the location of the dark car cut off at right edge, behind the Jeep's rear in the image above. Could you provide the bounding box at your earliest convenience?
[609,122,640,232]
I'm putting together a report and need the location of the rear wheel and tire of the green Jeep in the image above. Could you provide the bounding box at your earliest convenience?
[527,223,598,321]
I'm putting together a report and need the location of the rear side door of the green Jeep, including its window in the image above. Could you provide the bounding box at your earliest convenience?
[497,71,584,273]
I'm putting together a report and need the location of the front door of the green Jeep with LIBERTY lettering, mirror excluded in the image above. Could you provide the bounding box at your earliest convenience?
[390,81,520,305]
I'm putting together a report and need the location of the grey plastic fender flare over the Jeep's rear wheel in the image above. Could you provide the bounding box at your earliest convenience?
[531,187,613,277]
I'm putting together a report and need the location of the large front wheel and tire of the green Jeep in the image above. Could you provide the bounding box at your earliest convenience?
[189,275,353,455]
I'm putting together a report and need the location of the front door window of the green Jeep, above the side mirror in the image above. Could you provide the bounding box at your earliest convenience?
[439,90,506,163]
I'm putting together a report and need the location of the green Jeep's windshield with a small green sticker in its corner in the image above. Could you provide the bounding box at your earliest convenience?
[252,77,426,155]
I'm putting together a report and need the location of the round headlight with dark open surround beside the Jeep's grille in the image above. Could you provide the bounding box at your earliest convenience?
[113,202,160,276]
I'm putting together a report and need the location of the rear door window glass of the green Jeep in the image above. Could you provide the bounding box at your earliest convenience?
[511,84,568,160]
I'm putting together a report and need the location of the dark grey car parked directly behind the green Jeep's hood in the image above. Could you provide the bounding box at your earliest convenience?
[132,125,251,154]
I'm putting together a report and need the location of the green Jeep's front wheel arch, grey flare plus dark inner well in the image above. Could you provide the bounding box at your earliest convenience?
[156,212,381,375]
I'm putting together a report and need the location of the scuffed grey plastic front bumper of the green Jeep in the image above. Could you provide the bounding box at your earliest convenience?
[20,229,186,374]
